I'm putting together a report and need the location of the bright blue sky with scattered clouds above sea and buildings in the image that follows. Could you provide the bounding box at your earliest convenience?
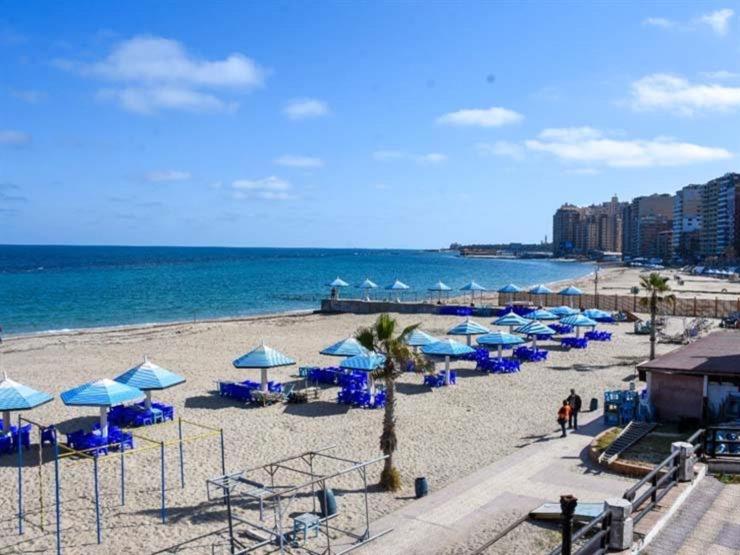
[0,0,740,248]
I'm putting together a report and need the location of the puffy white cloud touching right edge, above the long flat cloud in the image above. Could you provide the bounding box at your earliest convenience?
[632,73,740,115]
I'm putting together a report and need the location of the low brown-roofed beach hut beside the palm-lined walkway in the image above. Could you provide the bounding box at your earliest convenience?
[637,330,740,422]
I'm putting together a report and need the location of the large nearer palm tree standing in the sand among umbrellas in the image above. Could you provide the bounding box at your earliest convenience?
[355,314,431,491]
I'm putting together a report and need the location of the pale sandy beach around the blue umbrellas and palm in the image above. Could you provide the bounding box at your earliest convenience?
[0,268,720,554]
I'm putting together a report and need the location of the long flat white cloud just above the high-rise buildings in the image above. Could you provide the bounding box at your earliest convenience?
[525,127,733,167]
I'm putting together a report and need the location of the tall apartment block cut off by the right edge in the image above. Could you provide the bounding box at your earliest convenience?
[699,173,740,260]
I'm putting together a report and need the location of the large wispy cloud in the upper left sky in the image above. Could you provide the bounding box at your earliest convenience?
[60,37,264,114]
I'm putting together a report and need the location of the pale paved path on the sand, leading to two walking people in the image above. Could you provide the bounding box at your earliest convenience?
[357,412,634,555]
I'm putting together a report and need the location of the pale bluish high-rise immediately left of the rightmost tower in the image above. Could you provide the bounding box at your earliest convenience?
[671,185,704,263]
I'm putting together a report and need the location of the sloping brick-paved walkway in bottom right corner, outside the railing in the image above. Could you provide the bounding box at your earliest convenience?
[643,476,740,555]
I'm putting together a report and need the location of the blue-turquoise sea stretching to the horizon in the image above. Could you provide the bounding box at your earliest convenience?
[0,245,593,335]
